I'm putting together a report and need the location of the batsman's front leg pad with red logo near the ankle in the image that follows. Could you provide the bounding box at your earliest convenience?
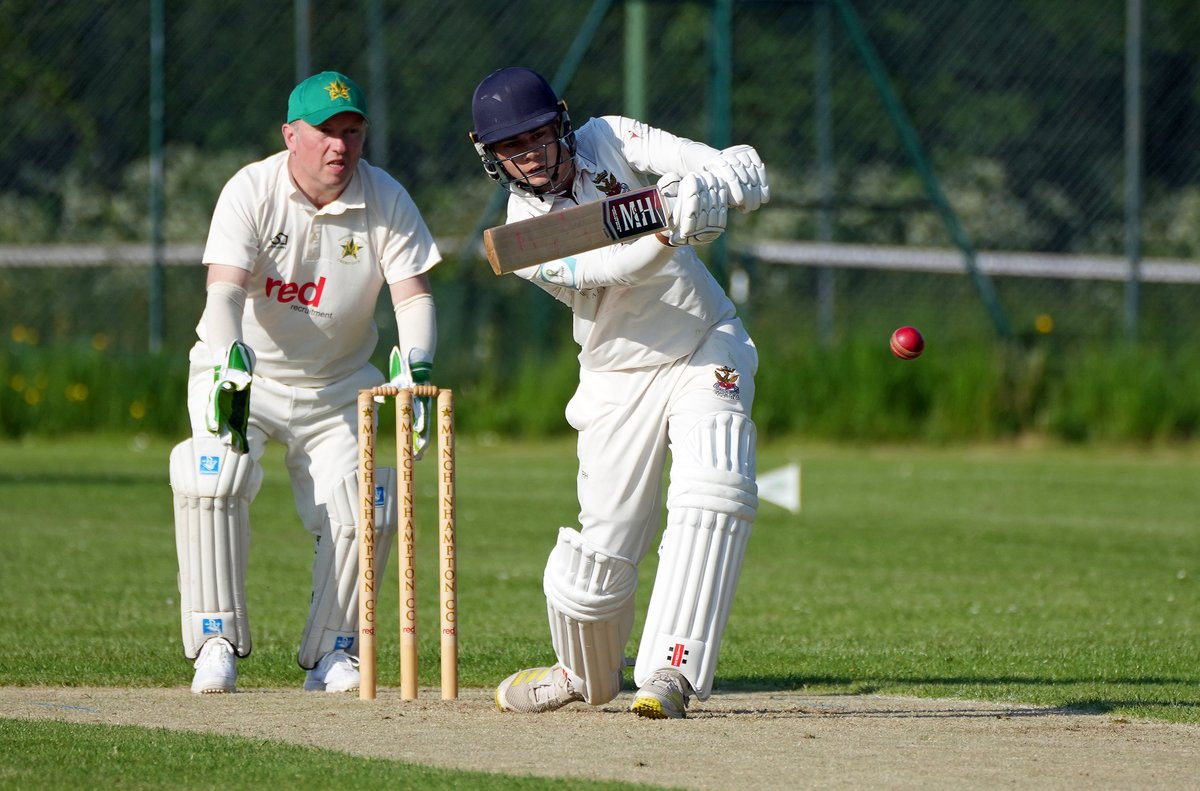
[634,413,758,700]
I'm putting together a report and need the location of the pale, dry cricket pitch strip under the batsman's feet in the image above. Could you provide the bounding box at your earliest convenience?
[0,687,1200,791]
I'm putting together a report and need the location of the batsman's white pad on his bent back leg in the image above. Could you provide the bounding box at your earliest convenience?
[542,527,637,705]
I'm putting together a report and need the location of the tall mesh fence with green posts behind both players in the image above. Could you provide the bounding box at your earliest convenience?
[0,0,1200,365]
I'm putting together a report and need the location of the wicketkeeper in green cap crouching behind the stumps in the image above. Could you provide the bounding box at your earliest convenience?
[170,72,440,694]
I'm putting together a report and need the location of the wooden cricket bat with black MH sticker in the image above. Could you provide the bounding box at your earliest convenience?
[484,187,668,275]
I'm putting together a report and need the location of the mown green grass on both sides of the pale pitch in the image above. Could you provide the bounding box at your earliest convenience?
[0,437,1200,787]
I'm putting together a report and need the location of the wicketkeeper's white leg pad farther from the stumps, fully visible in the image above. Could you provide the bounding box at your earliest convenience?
[170,437,263,659]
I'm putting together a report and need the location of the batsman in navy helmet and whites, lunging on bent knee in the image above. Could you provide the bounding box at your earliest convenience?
[470,67,769,719]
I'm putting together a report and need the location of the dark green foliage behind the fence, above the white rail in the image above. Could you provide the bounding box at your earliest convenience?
[0,0,1200,254]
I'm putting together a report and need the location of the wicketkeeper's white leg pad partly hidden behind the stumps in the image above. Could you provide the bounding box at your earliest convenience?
[296,467,397,670]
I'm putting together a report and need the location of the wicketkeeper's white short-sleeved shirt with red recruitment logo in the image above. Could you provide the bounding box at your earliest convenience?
[197,150,442,386]
